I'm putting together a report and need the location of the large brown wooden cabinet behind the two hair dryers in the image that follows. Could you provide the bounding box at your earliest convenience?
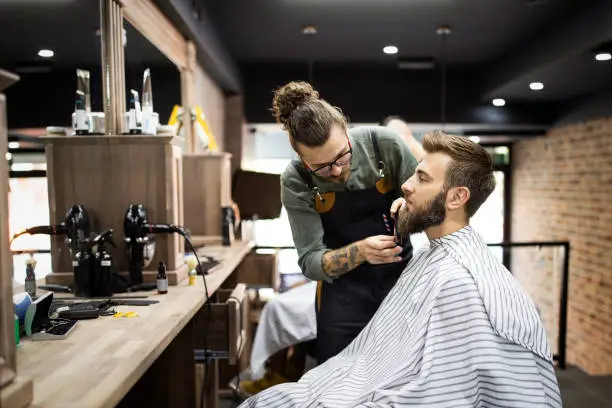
[43,136,187,284]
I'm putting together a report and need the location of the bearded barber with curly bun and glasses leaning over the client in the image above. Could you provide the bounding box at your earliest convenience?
[272,82,417,364]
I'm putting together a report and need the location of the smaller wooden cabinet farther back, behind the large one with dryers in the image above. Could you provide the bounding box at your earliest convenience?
[183,153,232,243]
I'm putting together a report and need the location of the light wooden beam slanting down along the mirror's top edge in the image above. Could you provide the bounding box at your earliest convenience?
[122,0,189,70]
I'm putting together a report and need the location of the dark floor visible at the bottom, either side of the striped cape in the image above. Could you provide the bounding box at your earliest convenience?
[219,367,612,408]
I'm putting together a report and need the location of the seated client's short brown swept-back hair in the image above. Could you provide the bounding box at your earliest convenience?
[423,130,495,218]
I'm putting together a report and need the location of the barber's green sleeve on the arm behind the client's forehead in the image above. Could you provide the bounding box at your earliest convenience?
[376,126,418,196]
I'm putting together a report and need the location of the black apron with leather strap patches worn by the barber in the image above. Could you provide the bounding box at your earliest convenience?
[293,132,412,364]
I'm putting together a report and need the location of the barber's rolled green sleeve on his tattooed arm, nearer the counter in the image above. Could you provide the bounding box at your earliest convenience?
[281,170,332,282]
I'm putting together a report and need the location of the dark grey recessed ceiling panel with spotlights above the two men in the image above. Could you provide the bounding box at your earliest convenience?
[203,0,584,65]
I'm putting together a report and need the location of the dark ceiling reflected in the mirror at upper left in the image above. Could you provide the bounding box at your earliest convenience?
[0,0,170,73]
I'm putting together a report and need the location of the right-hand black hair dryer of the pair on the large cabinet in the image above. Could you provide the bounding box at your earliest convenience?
[123,204,187,284]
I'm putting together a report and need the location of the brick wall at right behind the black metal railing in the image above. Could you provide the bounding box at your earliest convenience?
[512,118,612,375]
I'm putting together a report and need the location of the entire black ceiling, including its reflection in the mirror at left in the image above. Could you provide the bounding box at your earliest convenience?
[0,0,612,128]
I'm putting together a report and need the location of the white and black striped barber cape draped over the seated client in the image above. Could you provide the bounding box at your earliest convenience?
[241,226,562,408]
